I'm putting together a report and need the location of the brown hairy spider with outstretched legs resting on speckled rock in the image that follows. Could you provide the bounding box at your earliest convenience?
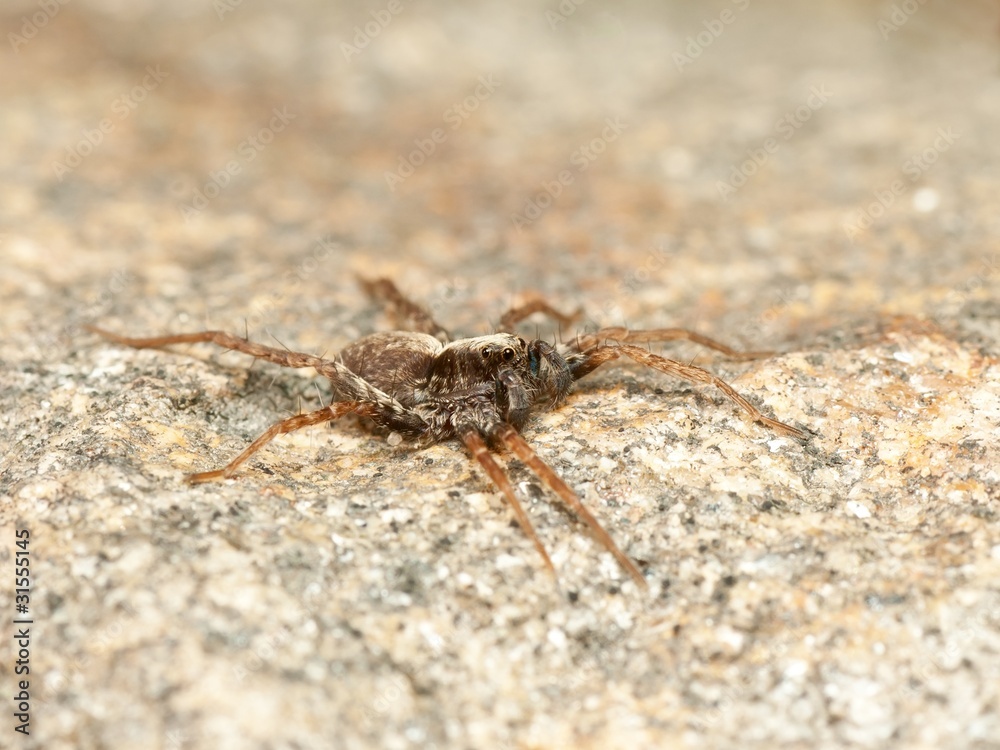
[88,278,806,588]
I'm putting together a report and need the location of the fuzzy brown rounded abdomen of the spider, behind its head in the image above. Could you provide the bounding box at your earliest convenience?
[340,331,441,406]
